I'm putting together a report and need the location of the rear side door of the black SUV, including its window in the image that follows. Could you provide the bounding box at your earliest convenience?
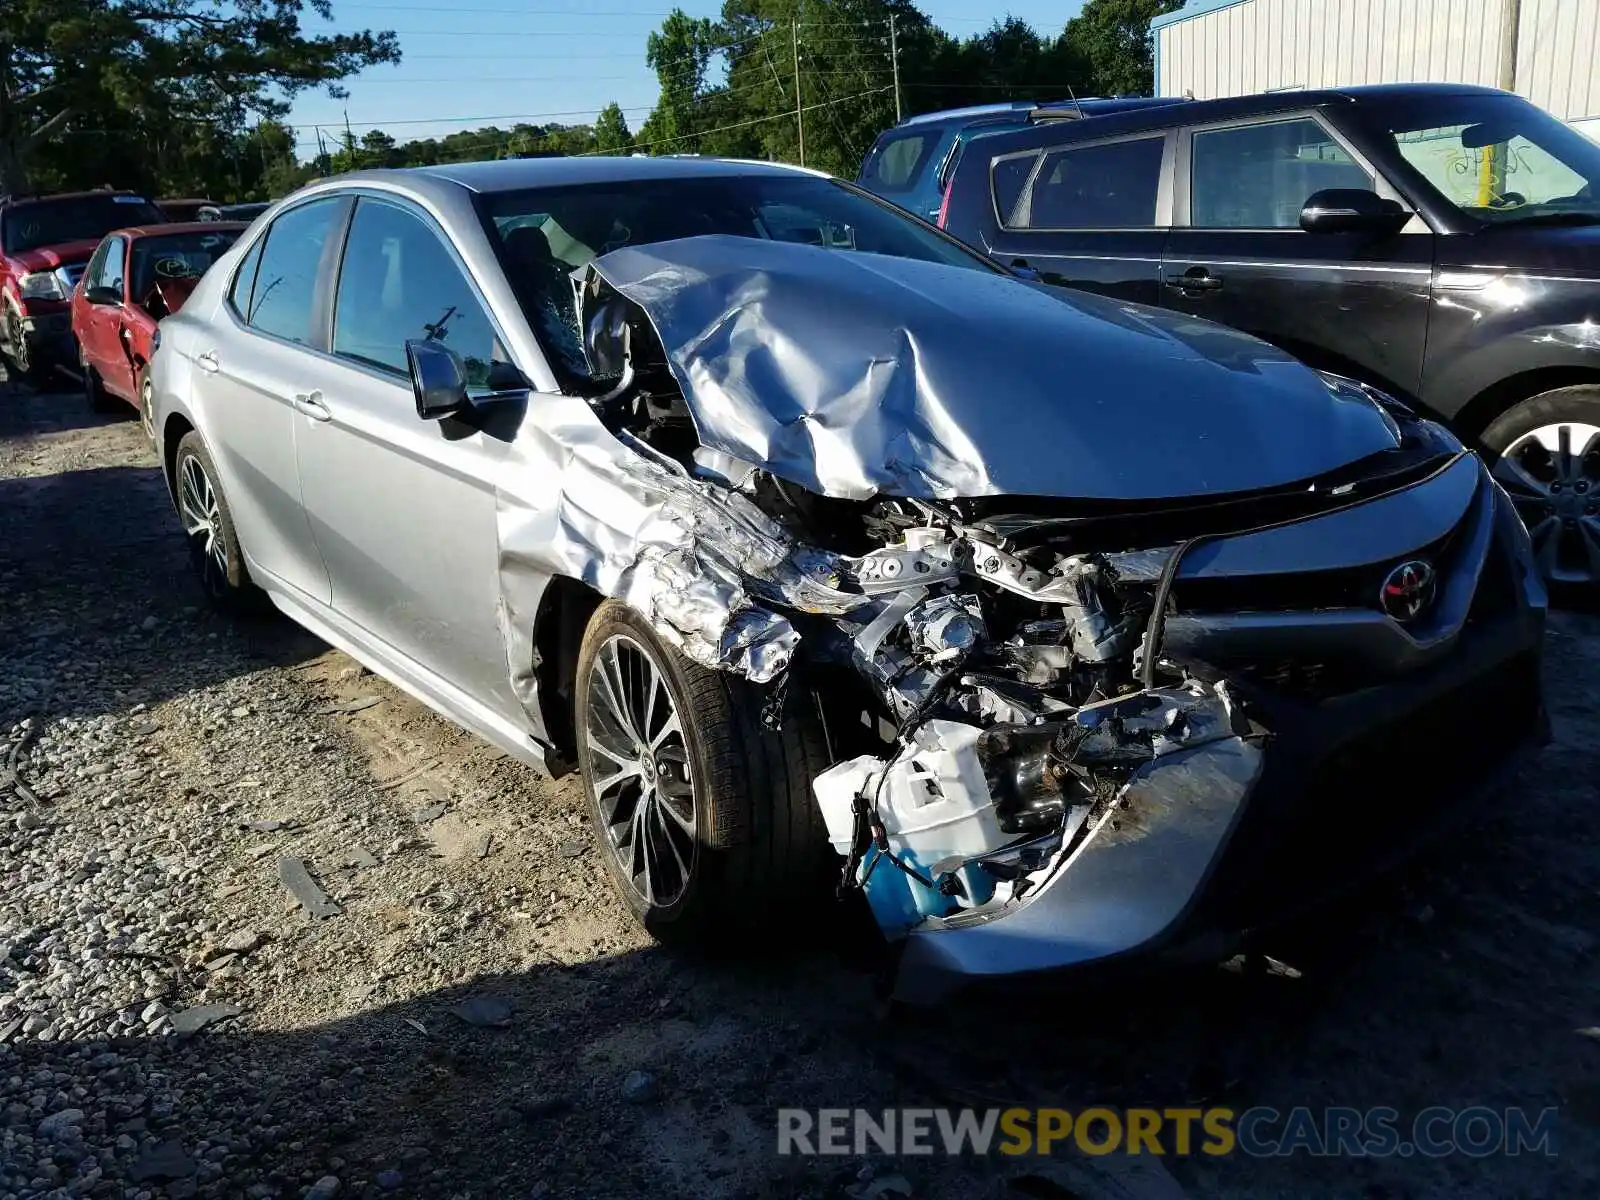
[979,131,1174,304]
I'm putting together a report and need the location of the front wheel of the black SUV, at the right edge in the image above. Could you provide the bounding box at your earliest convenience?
[1483,386,1600,589]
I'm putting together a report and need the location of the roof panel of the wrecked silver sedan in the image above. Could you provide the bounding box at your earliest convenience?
[337,154,826,192]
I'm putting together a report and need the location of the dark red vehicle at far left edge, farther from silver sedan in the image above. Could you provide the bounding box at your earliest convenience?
[0,190,166,378]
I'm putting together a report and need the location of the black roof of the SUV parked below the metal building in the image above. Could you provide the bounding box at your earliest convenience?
[953,83,1512,155]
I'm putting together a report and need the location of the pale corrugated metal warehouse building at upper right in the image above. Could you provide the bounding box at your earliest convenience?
[1150,0,1600,138]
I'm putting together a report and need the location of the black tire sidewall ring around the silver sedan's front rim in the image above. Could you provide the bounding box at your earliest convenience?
[573,600,715,939]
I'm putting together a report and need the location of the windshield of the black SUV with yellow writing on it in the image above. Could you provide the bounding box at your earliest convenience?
[1386,93,1600,226]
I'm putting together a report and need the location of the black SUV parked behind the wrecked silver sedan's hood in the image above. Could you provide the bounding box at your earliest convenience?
[944,83,1600,584]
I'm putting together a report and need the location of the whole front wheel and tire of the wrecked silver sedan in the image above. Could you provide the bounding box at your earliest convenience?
[574,600,827,946]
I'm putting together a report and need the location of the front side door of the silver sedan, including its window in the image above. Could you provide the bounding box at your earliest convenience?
[298,195,520,715]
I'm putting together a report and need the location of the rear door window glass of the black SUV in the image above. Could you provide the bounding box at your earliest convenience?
[1002,134,1166,229]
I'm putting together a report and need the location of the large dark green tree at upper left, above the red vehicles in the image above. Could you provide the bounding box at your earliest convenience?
[0,0,400,190]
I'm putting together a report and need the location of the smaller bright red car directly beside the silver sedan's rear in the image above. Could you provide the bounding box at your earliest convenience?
[72,221,248,434]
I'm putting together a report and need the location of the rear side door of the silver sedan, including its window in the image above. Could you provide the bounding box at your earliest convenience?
[192,197,349,605]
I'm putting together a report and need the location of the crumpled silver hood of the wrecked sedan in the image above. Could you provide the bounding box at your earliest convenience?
[590,235,1397,501]
